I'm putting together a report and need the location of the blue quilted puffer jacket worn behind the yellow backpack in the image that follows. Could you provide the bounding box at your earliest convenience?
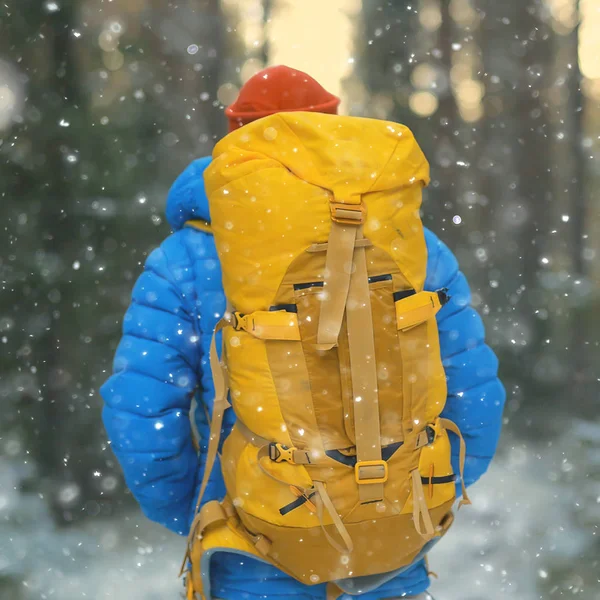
[101,158,505,600]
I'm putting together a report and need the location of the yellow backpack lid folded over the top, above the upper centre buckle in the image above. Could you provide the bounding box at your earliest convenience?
[205,112,429,204]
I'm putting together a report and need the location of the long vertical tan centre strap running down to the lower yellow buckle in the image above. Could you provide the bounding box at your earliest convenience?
[346,229,385,504]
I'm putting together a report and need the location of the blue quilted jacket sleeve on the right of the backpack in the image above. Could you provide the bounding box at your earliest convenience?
[425,230,505,489]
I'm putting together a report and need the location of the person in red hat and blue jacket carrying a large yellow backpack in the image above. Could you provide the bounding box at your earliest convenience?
[101,66,505,600]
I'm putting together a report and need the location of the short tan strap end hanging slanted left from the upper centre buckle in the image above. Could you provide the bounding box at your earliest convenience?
[317,221,358,350]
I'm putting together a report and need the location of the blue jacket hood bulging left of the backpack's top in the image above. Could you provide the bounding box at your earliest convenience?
[166,156,211,231]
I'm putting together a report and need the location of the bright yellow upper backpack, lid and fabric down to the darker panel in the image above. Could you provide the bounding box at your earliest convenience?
[204,112,429,313]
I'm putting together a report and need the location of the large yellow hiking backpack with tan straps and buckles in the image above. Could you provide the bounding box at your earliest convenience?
[184,113,469,599]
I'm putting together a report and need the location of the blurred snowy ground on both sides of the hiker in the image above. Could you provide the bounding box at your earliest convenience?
[0,423,600,600]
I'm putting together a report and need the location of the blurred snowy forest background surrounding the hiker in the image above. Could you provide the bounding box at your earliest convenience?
[0,0,600,600]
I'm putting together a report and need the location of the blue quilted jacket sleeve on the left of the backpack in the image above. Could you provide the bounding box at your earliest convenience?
[101,232,201,534]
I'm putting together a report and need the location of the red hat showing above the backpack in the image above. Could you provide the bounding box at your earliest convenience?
[225,66,340,131]
